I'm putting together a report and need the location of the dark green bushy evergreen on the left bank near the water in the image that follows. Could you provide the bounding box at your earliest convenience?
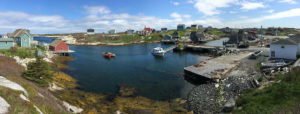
[22,57,53,86]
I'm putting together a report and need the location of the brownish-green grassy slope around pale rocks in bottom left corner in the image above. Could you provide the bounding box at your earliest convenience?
[0,56,65,114]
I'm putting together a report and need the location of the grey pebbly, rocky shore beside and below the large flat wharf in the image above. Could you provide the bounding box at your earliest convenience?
[186,55,260,114]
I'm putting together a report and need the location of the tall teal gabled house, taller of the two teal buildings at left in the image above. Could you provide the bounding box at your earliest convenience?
[7,29,33,47]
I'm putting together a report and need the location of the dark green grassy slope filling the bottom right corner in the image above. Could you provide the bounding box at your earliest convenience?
[233,67,300,114]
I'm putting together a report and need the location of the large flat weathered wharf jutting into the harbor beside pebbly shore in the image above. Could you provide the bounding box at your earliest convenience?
[184,52,252,81]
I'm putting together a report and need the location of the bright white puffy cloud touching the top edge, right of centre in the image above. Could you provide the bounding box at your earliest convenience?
[194,0,237,16]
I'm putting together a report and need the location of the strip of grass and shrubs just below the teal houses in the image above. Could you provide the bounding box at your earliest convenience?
[0,46,46,58]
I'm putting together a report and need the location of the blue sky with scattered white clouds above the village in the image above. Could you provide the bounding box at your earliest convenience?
[0,0,300,34]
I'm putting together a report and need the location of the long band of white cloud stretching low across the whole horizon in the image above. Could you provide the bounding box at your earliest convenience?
[0,5,300,33]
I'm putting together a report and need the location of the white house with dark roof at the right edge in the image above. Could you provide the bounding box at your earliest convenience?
[270,35,300,60]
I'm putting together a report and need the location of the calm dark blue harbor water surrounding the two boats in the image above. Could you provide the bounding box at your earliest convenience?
[63,39,224,100]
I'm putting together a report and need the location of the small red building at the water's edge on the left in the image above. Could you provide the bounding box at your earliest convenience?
[49,40,69,55]
